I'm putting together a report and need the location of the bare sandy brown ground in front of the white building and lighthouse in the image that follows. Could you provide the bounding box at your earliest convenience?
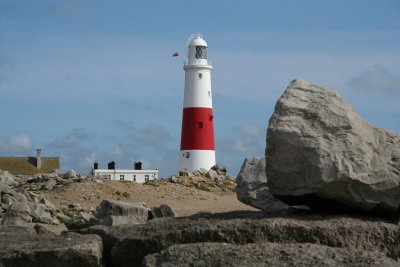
[43,181,256,216]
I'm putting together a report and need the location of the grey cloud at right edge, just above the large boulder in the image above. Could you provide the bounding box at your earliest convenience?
[350,65,400,93]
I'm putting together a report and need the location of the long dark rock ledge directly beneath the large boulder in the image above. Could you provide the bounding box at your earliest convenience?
[77,215,400,266]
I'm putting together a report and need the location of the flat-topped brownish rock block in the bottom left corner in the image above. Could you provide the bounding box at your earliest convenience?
[0,226,102,267]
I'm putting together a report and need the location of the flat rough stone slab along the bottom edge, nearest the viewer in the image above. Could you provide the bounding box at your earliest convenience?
[143,242,399,267]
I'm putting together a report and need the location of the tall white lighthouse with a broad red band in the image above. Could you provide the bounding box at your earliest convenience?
[180,35,215,170]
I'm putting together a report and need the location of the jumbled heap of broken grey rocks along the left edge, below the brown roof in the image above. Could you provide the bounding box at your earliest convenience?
[0,170,115,227]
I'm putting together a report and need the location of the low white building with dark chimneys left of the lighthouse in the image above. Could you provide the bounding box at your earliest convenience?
[93,161,158,183]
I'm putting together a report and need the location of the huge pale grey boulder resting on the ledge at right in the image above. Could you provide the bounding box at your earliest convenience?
[266,80,400,214]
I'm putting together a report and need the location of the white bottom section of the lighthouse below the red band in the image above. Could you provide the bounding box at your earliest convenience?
[180,150,215,171]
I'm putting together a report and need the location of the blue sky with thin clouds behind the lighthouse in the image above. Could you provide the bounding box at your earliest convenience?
[0,0,400,177]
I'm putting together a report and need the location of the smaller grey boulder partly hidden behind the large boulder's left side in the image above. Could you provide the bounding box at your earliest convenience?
[236,157,290,212]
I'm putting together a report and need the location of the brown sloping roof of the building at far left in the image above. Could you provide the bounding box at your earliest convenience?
[0,157,60,175]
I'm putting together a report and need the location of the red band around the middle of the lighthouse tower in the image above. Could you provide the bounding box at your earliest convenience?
[181,108,215,150]
